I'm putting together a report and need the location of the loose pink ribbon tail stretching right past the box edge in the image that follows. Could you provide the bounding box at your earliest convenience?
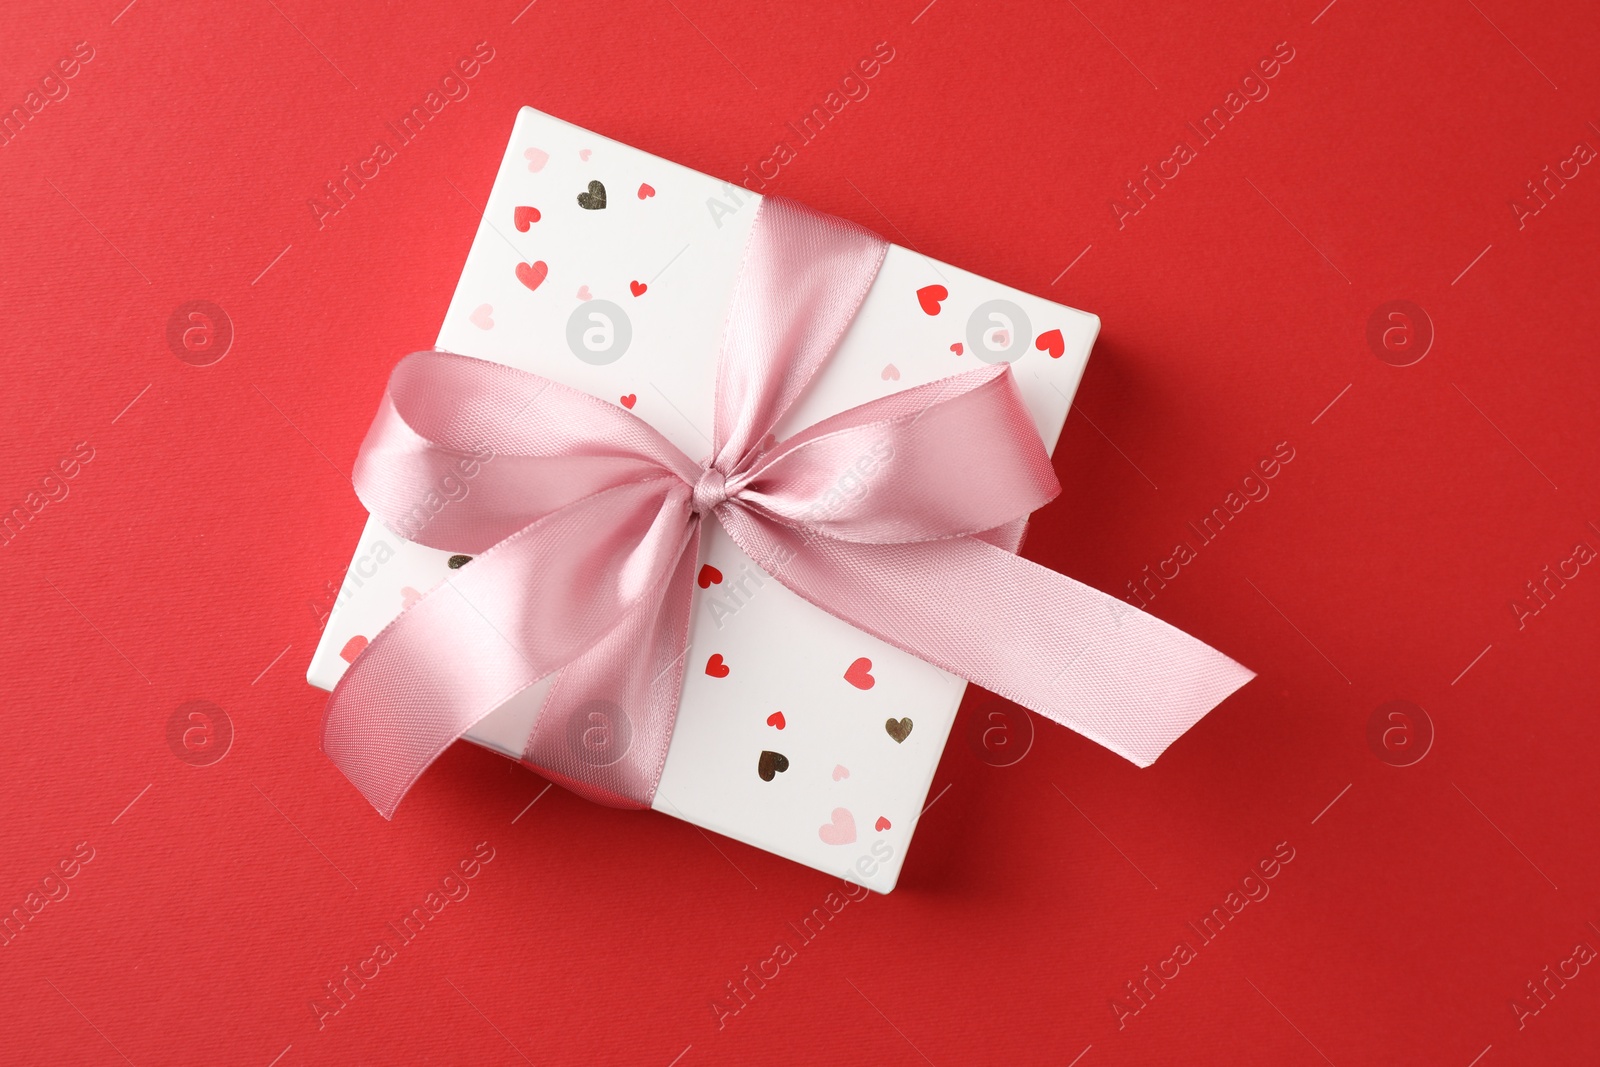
[723,509,1256,766]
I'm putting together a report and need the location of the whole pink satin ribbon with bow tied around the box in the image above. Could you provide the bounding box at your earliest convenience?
[323,198,1254,817]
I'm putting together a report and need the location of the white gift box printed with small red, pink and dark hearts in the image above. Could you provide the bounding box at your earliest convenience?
[307,107,1099,893]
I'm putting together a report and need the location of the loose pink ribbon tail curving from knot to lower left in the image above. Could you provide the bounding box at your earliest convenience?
[322,478,688,819]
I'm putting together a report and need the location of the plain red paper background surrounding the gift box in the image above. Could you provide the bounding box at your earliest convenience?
[0,0,1600,1067]
